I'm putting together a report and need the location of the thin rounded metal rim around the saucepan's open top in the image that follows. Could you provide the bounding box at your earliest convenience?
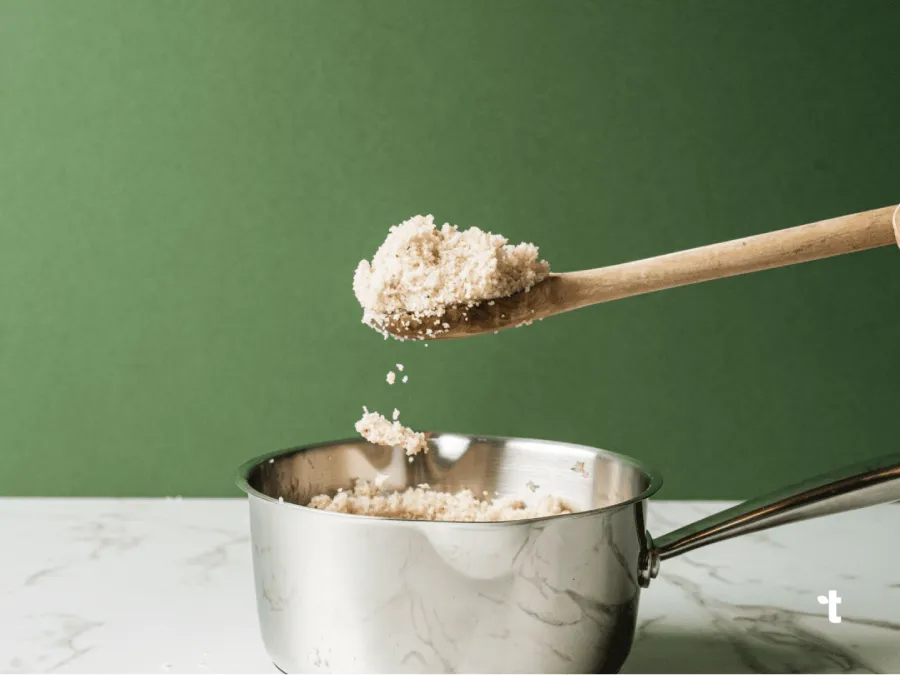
[235,431,663,529]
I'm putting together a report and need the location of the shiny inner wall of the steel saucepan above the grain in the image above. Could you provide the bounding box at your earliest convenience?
[238,434,662,510]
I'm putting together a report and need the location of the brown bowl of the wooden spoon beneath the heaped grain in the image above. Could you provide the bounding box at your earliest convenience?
[366,275,558,341]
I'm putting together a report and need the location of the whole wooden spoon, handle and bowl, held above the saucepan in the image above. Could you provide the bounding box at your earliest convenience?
[374,206,900,340]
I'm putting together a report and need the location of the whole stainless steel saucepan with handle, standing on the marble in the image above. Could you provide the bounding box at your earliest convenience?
[238,434,900,673]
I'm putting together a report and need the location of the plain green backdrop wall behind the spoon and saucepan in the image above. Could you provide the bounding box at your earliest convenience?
[0,0,900,498]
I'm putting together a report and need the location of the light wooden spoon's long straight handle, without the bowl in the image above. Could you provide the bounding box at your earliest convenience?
[556,201,900,311]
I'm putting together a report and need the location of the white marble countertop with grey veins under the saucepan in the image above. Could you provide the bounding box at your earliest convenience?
[0,499,900,673]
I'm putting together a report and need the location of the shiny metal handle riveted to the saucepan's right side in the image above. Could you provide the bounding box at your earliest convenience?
[640,454,900,586]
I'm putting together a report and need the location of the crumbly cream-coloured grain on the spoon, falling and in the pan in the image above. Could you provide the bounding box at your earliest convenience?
[326,216,573,522]
